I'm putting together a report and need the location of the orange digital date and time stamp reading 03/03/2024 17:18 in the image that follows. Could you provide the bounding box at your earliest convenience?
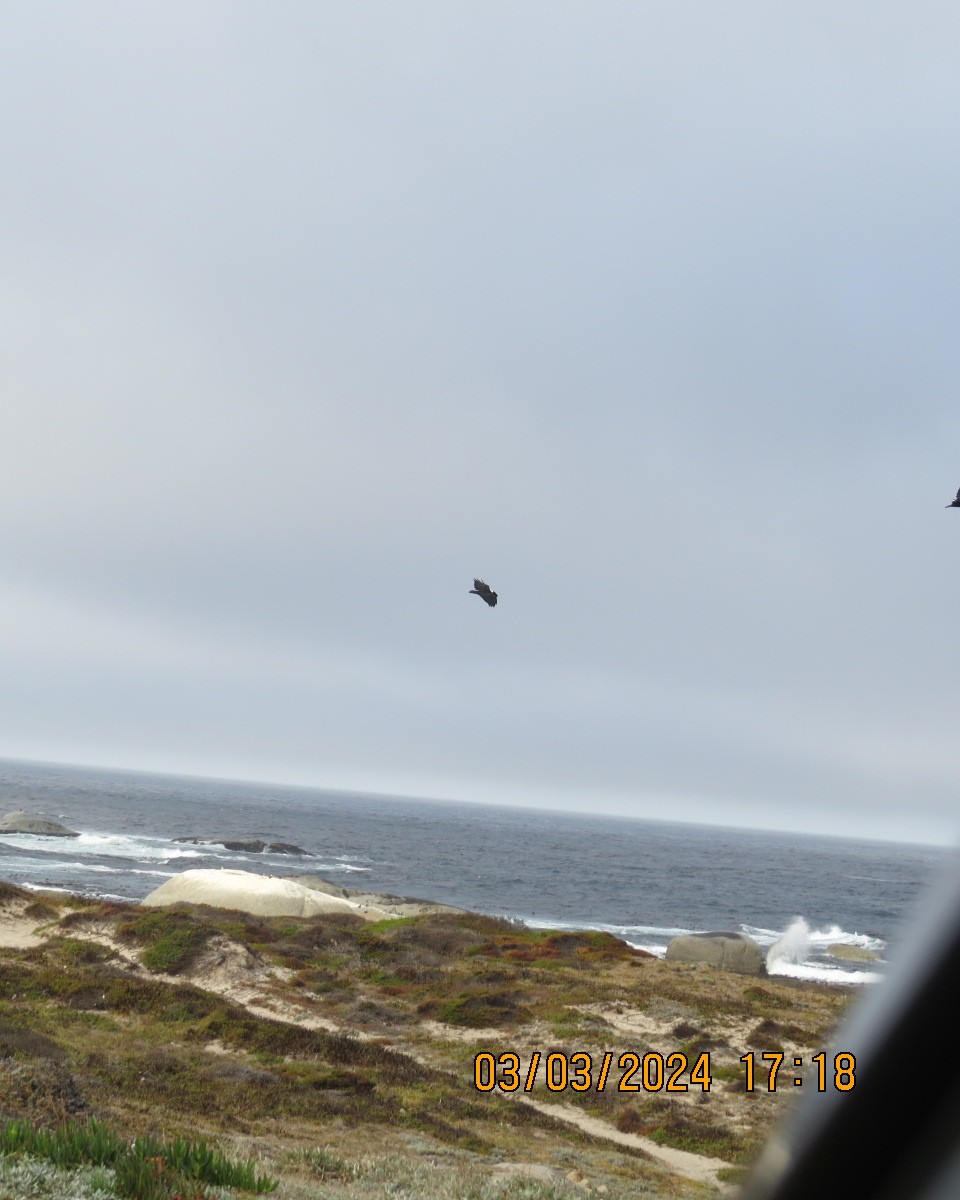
[473,1050,857,1092]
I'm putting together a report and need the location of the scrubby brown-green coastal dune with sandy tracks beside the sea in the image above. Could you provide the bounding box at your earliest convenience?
[0,884,848,1200]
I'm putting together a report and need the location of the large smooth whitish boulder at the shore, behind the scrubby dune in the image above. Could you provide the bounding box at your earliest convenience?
[140,869,389,920]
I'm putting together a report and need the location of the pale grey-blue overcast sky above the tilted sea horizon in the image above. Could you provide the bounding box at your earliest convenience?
[0,0,960,841]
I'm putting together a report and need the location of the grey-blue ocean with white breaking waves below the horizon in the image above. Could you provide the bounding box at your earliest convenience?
[0,761,953,984]
